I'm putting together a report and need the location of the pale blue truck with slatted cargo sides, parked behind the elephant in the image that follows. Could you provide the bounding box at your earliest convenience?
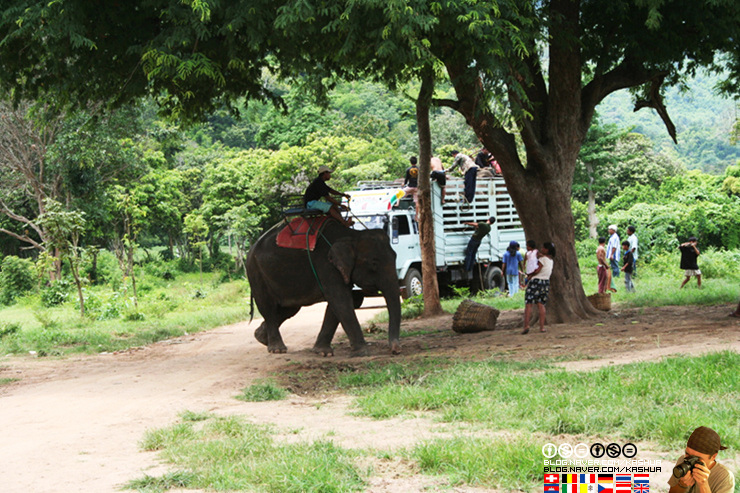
[347,178,525,297]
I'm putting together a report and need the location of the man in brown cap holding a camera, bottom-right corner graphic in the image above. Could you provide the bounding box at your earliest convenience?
[668,426,735,493]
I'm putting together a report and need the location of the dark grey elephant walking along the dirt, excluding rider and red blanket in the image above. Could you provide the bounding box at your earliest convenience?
[247,219,401,356]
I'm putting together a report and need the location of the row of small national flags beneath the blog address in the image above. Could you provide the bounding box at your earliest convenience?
[544,473,650,493]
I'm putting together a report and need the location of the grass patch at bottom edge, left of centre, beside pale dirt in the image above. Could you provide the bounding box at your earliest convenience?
[132,417,366,493]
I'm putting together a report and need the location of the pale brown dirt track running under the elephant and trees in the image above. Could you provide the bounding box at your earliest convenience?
[0,305,740,493]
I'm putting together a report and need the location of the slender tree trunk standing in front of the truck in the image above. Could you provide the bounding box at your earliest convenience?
[416,68,442,317]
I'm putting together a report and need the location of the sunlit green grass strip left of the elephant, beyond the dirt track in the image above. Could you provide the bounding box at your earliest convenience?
[0,274,249,356]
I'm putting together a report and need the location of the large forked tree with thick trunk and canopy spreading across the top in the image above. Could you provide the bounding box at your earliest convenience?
[0,0,740,321]
